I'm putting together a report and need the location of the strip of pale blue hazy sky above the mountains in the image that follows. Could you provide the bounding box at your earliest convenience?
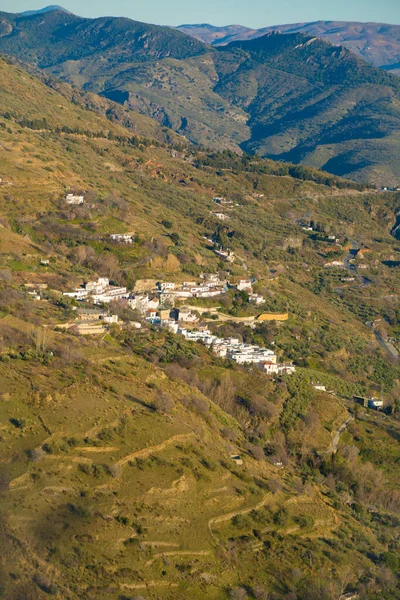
[0,0,400,27]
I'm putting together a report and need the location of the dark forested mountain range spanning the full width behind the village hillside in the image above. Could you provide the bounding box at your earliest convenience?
[0,10,400,185]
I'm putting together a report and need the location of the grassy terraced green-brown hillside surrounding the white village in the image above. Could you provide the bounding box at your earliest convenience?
[0,59,400,600]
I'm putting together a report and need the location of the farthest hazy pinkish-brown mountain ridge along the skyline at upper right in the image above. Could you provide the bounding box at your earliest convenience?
[177,21,400,74]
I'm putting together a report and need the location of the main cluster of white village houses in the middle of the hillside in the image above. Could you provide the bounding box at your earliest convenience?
[59,273,294,375]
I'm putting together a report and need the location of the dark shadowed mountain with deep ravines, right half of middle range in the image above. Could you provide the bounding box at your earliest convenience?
[216,34,400,185]
